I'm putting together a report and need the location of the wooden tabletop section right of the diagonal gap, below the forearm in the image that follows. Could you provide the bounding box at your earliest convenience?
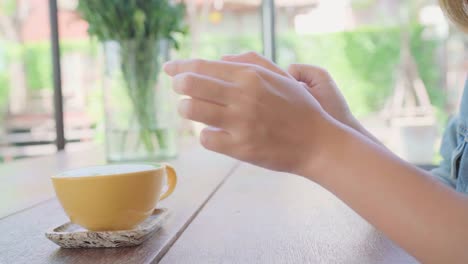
[161,164,416,264]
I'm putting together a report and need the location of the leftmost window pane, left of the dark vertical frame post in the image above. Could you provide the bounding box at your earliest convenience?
[0,0,56,163]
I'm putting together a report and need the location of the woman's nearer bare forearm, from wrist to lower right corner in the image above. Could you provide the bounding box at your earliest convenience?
[304,125,468,263]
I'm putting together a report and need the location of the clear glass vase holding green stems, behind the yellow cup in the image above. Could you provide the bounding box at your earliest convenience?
[103,39,177,162]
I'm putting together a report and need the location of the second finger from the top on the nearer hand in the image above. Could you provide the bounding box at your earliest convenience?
[173,72,235,105]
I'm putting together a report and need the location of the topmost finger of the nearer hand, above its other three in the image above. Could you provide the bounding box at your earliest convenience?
[164,59,239,81]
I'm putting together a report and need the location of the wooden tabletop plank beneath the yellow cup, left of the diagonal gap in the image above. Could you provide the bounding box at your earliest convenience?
[0,147,238,264]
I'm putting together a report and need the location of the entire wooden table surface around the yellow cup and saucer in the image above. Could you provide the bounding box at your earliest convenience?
[0,143,416,264]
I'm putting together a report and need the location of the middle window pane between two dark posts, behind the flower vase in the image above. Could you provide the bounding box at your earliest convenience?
[54,0,262,153]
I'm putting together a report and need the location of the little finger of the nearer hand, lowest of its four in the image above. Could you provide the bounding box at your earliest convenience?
[200,127,234,154]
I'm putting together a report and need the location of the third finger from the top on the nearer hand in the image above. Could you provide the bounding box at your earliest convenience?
[178,99,230,128]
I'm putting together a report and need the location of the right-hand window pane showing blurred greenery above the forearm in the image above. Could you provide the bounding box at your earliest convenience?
[276,0,468,164]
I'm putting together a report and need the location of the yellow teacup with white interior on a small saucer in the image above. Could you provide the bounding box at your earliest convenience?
[52,164,177,231]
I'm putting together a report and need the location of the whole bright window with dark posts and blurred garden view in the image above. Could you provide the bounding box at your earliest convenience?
[0,0,468,164]
